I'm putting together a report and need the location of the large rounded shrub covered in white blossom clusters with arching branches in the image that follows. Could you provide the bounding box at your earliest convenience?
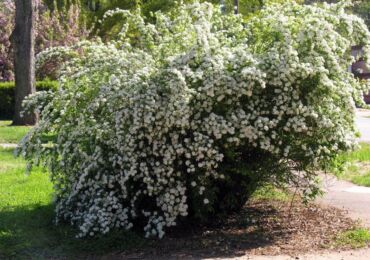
[18,2,370,237]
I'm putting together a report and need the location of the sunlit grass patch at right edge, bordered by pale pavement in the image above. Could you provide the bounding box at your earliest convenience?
[336,143,370,187]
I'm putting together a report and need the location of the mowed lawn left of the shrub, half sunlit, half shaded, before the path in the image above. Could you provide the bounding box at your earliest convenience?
[0,148,149,259]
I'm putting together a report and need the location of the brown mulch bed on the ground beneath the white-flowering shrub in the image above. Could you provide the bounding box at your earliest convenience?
[110,200,356,259]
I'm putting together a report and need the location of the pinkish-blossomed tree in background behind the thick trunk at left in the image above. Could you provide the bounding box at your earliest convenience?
[0,0,91,81]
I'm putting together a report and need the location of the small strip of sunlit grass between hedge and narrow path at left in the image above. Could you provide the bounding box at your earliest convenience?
[0,120,31,143]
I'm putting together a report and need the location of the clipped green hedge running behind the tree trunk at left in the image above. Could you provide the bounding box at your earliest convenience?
[0,81,58,119]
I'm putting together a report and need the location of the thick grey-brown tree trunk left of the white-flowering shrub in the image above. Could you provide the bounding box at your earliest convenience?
[11,0,38,125]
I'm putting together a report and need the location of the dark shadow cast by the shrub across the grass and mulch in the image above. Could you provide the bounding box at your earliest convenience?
[0,199,344,259]
